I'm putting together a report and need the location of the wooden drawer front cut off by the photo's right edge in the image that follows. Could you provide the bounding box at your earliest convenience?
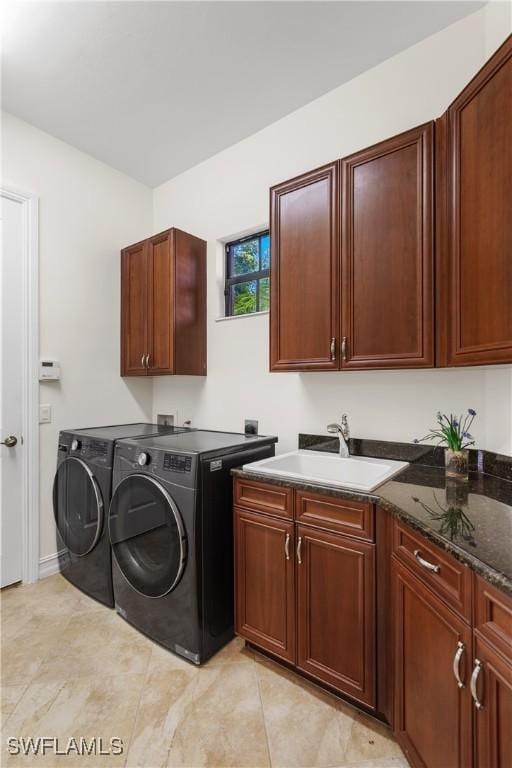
[474,576,512,660]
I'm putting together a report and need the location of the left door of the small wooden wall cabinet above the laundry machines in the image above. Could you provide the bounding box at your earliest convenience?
[121,238,149,376]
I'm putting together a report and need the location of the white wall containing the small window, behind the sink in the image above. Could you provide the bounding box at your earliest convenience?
[153,3,512,453]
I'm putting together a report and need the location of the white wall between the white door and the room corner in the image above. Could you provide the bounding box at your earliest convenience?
[2,113,152,557]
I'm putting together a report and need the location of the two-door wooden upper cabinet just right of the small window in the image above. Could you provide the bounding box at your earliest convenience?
[270,123,434,371]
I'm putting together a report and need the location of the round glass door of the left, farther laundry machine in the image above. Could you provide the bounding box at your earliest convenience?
[53,457,103,557]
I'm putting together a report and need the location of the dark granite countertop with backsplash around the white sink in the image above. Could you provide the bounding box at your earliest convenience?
[233,435,512,596]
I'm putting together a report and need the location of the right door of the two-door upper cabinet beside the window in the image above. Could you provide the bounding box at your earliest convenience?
[341,123,434,368]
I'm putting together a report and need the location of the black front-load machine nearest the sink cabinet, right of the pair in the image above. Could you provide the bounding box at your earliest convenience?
[109,430,277,664]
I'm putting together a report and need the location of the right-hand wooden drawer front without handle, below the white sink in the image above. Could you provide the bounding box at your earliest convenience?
[295,491,375,541]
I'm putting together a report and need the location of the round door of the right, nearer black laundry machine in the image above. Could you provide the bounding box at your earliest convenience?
[109,473,186,597]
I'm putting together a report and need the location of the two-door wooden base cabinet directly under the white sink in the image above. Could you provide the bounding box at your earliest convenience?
[234,478,376,709]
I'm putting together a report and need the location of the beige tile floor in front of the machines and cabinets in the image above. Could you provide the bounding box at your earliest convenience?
[0,575,407,768]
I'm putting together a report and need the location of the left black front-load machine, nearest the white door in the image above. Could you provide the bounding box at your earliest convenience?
[53,423,190,607]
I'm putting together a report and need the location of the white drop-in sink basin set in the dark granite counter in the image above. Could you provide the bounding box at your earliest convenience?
[243,451,408,491]
